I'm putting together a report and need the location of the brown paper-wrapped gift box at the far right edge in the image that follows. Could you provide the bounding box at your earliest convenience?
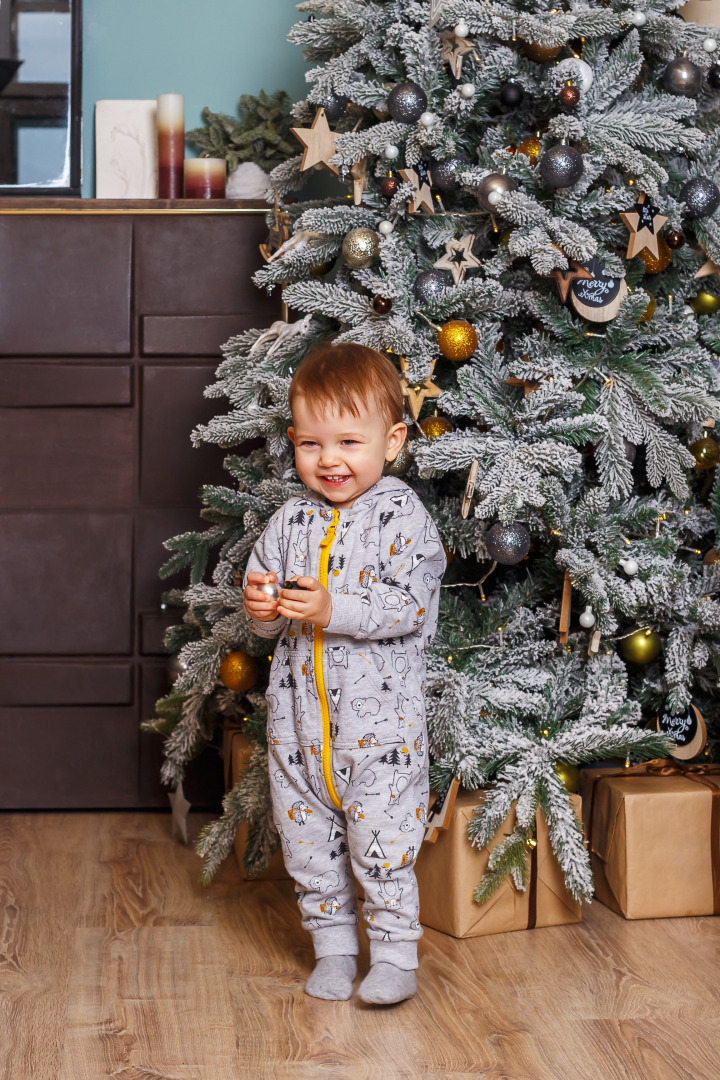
[581,758,720,919]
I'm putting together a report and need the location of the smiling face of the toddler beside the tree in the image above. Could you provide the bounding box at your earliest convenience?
[287,395,407,510]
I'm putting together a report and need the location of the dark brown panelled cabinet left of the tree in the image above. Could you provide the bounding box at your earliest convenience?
[0,200,280,809]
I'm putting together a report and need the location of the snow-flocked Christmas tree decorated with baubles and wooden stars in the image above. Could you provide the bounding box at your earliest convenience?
[140,0,720,900]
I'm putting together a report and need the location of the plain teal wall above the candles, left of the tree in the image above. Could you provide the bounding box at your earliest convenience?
[82,0,307,197]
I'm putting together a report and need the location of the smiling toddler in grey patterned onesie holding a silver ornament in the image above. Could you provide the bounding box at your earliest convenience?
[244,343,446,1004]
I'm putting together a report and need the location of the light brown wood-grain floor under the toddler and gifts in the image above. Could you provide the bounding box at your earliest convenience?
[0,812,720,1080]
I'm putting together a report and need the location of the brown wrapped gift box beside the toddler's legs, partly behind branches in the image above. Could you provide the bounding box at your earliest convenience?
[416,791,582,937]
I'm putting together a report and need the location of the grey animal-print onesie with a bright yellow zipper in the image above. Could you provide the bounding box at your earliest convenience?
[246,476,446,969]
